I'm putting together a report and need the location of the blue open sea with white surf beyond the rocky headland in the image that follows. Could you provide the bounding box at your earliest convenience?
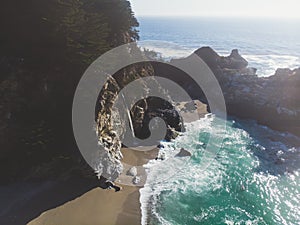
[139,17,300,76]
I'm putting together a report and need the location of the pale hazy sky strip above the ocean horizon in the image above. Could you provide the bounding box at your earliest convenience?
[130,0,300,18]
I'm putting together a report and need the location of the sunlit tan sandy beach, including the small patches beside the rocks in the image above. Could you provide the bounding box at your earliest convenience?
[28,101,207,225]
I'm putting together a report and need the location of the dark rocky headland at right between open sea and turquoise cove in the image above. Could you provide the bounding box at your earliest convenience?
[171,47,300,136]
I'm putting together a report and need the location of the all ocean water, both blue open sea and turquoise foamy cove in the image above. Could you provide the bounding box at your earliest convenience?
[139,18,300,225]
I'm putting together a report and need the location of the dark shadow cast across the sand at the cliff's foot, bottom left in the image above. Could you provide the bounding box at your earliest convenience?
[0,178,105,225]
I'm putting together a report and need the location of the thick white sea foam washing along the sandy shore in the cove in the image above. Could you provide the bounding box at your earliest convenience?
[140,116,218,225]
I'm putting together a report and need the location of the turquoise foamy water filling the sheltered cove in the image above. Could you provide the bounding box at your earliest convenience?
[140,116,300,225]
